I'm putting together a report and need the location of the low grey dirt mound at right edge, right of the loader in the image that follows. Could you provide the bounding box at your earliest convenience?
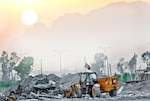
[124,80,150,91]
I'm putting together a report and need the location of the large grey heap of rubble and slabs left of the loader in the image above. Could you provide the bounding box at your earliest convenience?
[0,74,80,101]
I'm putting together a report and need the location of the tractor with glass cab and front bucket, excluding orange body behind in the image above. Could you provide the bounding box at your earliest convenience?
[63,72,100,98]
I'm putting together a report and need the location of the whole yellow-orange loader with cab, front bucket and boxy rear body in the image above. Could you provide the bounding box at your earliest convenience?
[63,72,118,98]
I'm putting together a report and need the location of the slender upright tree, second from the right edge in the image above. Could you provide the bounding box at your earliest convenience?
[129,54,137,80]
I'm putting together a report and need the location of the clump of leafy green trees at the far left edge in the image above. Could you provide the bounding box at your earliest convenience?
[0,51,34,81]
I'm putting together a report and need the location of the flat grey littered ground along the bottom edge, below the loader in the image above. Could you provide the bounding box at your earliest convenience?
[19,91,150,101]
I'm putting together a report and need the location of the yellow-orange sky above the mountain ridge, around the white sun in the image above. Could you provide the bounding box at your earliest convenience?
[0,0,146,50]
